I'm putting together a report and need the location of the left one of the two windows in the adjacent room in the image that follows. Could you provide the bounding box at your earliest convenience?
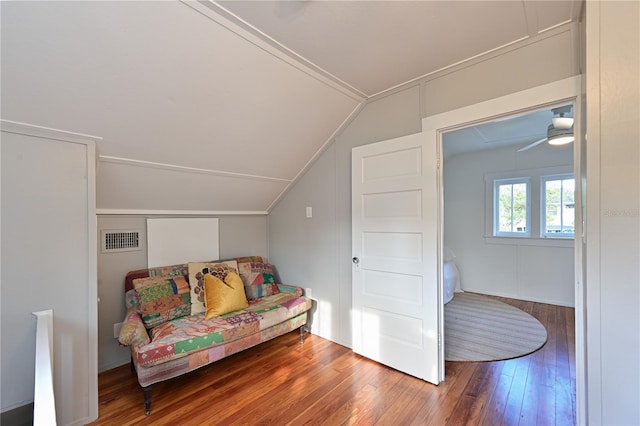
[493,178,531,237]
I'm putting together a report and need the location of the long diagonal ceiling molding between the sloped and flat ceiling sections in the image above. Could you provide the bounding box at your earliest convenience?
[180,0,367,102]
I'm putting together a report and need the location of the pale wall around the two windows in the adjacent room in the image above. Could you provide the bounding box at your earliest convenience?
[443,143,575,306]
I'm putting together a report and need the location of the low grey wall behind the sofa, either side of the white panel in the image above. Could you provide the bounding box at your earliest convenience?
[98,215,268,371]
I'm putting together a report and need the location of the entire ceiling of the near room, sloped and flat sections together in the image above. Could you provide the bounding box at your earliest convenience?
[0,0,580,213]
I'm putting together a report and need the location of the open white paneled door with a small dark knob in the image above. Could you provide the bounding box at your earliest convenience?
[352,133,442,384]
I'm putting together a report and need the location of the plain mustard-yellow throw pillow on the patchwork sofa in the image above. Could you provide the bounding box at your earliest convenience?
[204,272,249,319]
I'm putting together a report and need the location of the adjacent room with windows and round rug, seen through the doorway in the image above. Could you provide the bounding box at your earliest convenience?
[442,104,576,364]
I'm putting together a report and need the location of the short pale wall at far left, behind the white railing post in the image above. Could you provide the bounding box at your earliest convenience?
[0,122,98,425]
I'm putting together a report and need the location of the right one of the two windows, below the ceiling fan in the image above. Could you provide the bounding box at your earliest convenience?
[540,174,575,238]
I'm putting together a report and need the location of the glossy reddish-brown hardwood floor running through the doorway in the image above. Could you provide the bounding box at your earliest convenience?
[92,298,576,426]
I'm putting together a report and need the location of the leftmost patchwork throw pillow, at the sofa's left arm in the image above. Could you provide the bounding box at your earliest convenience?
[133,276,191,328]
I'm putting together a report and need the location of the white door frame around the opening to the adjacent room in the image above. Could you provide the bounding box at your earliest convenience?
[422,75,586,424]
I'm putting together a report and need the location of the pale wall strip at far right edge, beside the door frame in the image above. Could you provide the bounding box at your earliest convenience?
[586,1,640,425]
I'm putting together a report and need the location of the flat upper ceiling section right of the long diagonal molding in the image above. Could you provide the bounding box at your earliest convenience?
[218,0,581,96]
